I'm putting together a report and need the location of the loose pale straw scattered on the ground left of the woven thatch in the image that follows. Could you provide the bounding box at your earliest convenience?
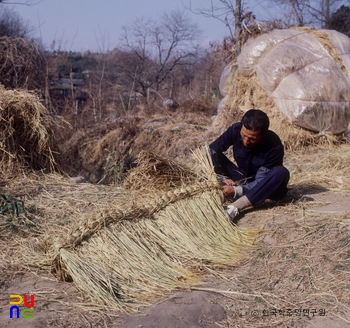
[0,172,128,275]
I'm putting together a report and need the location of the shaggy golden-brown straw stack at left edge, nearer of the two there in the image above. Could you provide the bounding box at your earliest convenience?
[0,87,59,174]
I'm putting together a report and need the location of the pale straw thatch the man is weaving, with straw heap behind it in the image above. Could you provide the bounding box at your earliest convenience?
[52,148,255,311]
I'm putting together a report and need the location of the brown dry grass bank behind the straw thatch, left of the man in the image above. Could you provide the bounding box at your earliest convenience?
[62,112,211,184]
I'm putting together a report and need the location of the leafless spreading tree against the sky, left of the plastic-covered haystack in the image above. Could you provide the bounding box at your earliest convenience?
[122,11,201,96]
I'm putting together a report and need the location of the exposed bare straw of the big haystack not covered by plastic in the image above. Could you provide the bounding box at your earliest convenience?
[213,28,344,150]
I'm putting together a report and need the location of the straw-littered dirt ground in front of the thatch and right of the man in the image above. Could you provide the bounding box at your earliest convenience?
[0,131,350,328]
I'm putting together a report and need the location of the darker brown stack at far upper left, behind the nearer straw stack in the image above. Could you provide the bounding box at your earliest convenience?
[0,37,46,90]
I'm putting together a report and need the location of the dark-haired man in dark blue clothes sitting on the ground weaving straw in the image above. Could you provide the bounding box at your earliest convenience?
[209,109,289,219]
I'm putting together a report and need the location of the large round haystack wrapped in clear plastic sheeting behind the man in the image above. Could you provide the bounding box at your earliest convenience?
[214,28,350,149]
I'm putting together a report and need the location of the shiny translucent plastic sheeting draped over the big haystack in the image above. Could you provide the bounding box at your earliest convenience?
[237,30,350,134]
